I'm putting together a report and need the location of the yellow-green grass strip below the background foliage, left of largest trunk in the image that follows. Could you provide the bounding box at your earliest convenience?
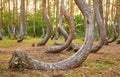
[0,36,83,47]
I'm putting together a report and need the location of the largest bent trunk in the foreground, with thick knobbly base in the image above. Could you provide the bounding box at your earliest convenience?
[9,0,94,70]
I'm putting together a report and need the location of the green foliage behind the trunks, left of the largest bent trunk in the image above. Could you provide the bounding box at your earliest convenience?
[3,10,85,38]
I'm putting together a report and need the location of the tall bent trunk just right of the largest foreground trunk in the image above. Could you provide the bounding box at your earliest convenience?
[91,0,105,53]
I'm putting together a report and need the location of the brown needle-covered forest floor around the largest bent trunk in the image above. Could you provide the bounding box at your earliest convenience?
[0,39,120,77]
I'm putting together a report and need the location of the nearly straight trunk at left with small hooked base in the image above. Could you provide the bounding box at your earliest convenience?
[17,0,25,42]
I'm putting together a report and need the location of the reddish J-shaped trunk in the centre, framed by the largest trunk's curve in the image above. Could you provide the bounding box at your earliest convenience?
[46,0,74,52]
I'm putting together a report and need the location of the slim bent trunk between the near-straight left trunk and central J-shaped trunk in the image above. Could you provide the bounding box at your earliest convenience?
[37,0,51,46]
